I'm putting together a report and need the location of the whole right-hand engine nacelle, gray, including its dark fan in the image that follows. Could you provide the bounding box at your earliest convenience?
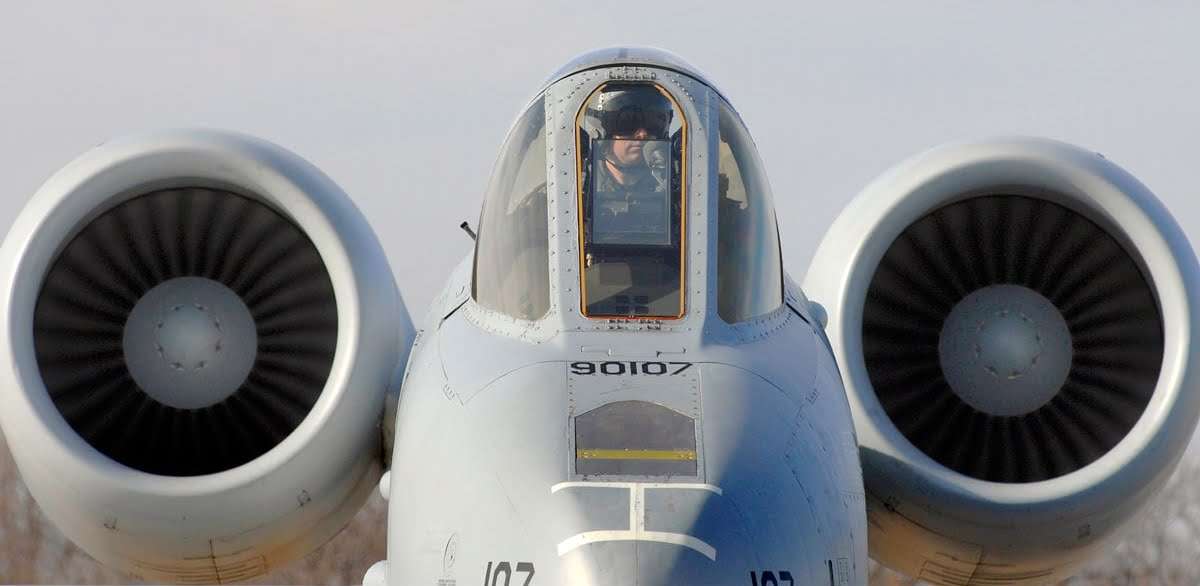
[804,138,1200,585]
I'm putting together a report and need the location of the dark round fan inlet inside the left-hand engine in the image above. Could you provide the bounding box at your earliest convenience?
[34,189,337,476]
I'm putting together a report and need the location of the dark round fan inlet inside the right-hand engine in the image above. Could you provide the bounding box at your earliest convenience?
[863,195,1163,483]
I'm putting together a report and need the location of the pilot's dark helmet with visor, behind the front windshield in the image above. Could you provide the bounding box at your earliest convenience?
[587,84,674,139]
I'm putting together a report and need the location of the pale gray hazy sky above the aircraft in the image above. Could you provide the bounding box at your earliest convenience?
[0,0,1200,432]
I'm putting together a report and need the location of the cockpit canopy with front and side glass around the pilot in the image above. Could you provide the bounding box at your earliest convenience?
[473,49,782,323]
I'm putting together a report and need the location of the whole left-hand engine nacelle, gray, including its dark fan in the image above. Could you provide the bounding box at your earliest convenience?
[0,131,413,584]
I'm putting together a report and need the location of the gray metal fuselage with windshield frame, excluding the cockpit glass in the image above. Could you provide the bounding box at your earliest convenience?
[379,52,866,586]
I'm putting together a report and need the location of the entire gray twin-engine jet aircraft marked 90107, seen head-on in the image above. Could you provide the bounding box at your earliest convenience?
[0,49,1200,586]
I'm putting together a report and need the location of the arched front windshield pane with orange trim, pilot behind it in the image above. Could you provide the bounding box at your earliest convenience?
[578,83,686,318]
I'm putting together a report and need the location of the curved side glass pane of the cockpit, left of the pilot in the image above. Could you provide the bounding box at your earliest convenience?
[473,98,550,319]
